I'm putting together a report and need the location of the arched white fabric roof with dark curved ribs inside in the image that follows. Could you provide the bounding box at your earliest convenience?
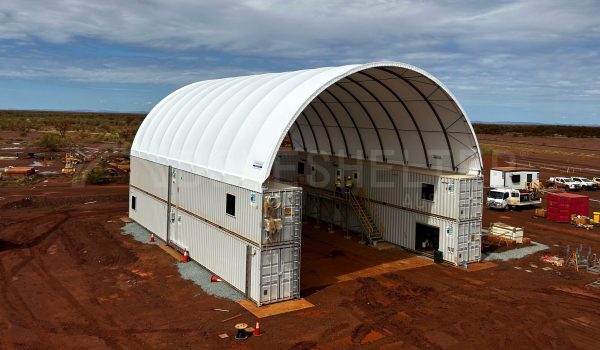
[131,62,482,192]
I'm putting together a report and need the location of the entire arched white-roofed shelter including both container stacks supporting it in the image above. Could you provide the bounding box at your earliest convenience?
[129,62,482,305]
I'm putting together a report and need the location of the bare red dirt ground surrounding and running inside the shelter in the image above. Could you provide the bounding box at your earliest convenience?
[0,138,600,349]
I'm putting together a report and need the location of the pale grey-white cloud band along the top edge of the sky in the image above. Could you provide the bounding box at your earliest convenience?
[0,0,600,57]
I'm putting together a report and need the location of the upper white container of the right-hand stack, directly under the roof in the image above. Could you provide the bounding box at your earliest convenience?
[273,152,483,220]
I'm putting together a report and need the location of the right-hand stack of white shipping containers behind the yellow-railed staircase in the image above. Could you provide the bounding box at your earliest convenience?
[272,152,483,264]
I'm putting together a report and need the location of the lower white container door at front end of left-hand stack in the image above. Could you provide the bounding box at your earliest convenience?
[260,245,300,304]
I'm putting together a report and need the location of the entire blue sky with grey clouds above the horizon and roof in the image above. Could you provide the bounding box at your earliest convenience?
[0,0,600,125]
